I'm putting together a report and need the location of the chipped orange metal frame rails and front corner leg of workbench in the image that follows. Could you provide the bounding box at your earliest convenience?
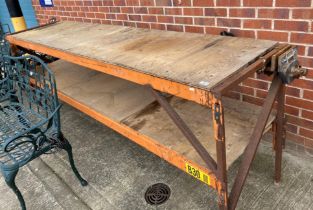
[6,32,286,210]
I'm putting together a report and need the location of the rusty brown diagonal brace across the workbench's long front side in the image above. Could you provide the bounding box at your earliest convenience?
[148,86,217,175]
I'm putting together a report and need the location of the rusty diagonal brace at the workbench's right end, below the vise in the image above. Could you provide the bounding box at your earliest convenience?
[229,75,283,210]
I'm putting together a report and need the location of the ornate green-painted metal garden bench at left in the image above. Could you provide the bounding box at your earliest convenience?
[0,44,88,210]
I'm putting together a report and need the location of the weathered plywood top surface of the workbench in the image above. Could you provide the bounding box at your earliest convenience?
[11,22,276,90]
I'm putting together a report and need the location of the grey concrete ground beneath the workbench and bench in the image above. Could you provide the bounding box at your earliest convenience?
[0,105,313,210]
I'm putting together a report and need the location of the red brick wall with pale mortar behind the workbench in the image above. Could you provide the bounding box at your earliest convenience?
[33,0,313,148]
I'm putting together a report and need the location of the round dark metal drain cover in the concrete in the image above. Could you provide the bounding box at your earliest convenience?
[145,183,171,205]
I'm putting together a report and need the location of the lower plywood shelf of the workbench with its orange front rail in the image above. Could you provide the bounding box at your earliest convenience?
[50,60,274,187]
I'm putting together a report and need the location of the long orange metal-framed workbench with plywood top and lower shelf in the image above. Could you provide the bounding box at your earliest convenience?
[6,22,298,209]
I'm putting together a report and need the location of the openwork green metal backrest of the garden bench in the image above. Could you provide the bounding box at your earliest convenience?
[0,55,60,131]
